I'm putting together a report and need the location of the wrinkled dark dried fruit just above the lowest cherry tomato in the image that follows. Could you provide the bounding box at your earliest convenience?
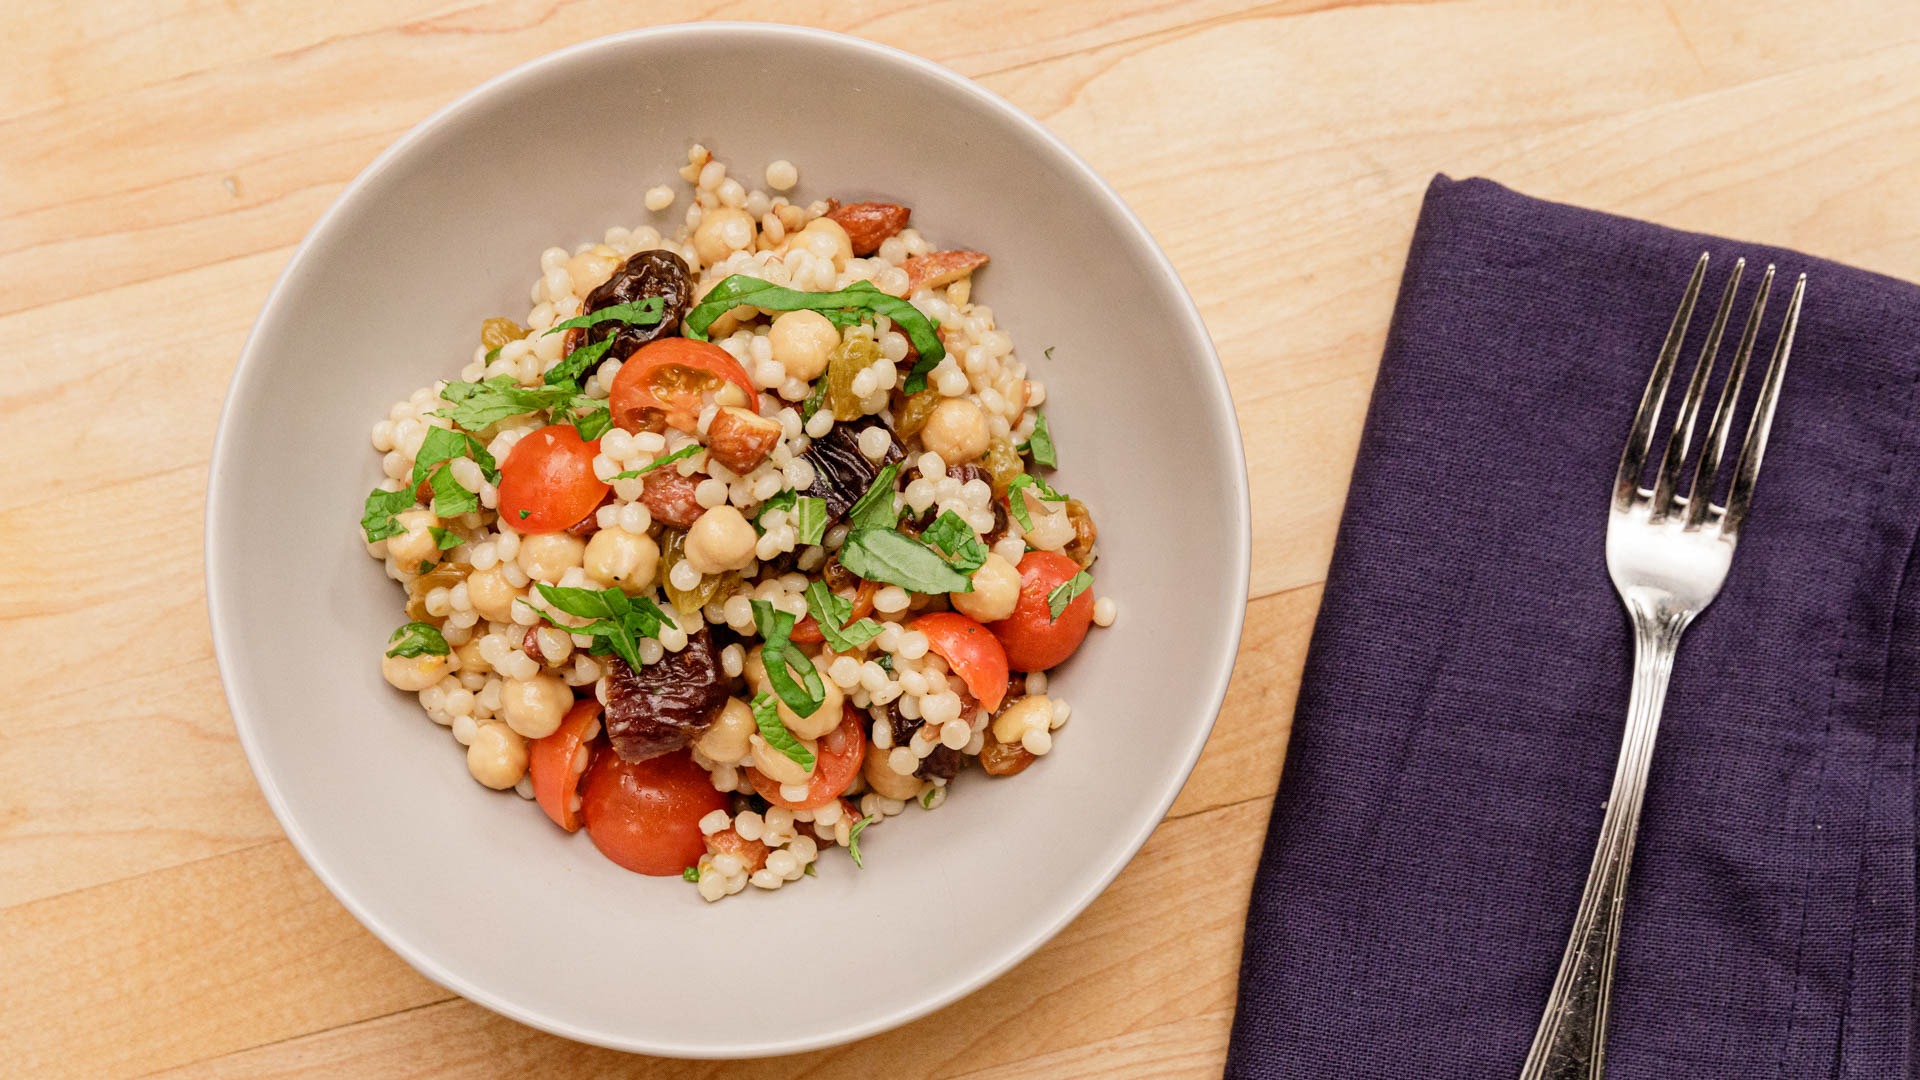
[607,626,728,761]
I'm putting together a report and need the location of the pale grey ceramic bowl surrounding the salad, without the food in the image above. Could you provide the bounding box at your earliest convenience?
[205,25,1248,1057]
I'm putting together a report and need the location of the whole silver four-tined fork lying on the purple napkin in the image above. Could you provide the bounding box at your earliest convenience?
[1521,254,1807,1080]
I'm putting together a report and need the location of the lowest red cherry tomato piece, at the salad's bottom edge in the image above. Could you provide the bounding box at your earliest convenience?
[580,749,728,878]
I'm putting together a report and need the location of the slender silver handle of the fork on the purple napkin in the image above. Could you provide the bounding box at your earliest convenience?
[1521,605,1690,1080]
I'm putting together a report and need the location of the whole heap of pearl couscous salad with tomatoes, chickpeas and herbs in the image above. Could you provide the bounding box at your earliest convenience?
[361,146,1117,899]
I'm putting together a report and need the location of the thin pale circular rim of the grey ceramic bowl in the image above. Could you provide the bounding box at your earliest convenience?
[202,21,1252,1059]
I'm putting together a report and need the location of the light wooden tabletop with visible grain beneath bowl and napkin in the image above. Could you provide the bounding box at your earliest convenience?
[0,0,1920,1078]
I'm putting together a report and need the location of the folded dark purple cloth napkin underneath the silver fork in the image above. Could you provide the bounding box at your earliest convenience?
[1227,177,1920,1080]
